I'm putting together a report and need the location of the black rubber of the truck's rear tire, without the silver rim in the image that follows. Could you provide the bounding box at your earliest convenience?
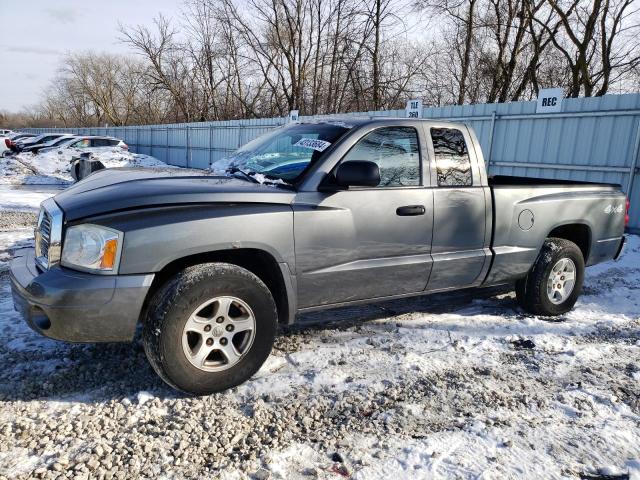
[516,238,584,317]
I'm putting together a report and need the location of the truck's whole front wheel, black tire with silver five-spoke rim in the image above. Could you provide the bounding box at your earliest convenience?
[142,263,278,395]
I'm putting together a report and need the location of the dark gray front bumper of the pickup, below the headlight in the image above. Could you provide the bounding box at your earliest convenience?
[11,248,153,342]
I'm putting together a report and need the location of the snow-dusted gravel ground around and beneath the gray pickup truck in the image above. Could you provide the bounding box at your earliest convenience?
[0,185,640,479]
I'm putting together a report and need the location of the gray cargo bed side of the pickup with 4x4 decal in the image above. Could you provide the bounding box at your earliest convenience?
[484,175,625,285]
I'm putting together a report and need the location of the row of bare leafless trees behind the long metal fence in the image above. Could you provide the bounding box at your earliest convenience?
[12,0,640,126]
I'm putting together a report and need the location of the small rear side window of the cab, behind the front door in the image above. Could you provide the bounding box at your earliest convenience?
[431,128,473,187]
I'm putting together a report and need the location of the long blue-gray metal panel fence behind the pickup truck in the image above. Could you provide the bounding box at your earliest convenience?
[25,94,640,231]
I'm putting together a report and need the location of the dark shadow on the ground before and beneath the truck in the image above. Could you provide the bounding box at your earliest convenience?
[0,275,516,404]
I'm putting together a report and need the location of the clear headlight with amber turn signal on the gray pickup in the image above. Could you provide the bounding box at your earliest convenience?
[61,224,122,273]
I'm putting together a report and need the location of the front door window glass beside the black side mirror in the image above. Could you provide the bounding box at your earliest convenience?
[342,127,420,187]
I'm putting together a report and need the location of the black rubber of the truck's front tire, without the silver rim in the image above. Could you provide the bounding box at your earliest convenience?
[142,263,278,395]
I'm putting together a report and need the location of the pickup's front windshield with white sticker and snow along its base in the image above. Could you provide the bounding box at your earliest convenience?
[218,122,350,183]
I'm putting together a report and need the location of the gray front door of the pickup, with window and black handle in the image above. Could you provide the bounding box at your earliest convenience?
[293,126,433,308]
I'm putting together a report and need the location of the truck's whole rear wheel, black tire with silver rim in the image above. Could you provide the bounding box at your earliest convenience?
[516,238,584,317]
